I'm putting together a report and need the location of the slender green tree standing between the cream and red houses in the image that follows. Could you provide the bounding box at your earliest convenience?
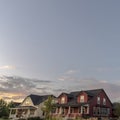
[42,96,55,120]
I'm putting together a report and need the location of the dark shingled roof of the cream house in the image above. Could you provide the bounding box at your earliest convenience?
[27,94,55,105]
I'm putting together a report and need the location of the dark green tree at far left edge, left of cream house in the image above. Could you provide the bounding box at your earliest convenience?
[0,99,9,117]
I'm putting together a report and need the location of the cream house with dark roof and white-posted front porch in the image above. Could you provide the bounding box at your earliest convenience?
[9,94,55,119]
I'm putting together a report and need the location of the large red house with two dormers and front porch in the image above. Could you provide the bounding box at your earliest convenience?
[53,89,112,119]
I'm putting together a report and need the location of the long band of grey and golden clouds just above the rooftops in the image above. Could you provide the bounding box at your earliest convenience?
[0,75,120,101]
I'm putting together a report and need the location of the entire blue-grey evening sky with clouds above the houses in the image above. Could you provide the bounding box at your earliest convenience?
[0,0,120,102]
